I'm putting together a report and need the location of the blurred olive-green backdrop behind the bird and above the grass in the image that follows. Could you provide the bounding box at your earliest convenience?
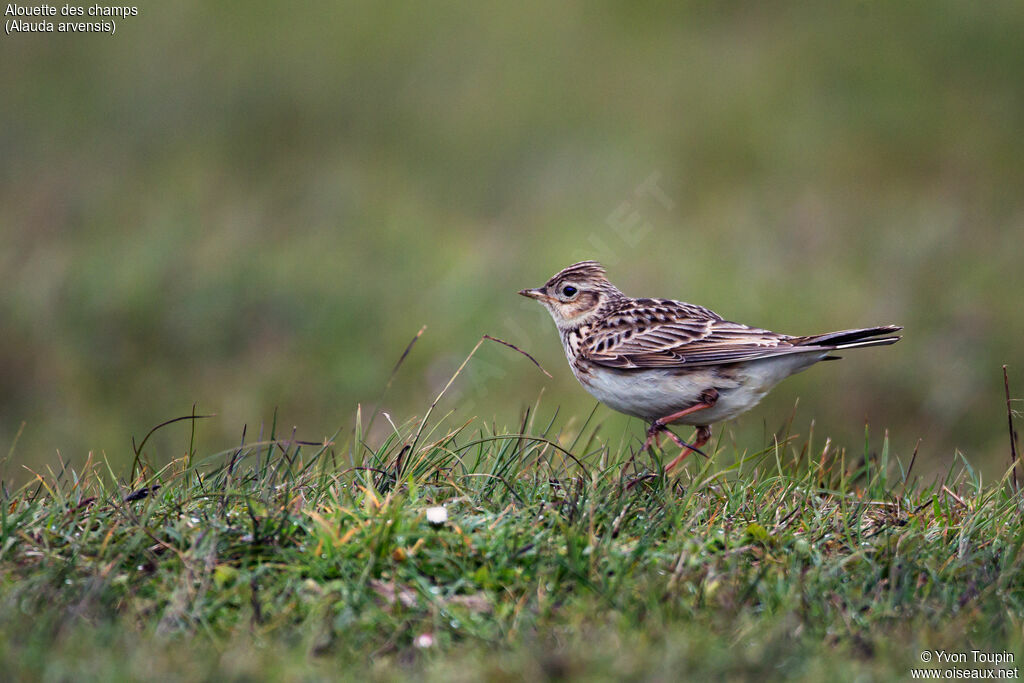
[0,1,1024,478]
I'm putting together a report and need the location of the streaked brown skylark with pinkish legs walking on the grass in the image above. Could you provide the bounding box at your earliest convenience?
[519,261,903,473]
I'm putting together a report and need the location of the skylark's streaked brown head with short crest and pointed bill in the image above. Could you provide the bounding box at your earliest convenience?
[519,261,624,330]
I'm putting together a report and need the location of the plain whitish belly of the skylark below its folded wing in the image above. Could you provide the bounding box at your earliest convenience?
[577,351,827,425]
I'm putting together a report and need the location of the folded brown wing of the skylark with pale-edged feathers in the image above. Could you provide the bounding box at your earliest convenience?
[581,299,807,370]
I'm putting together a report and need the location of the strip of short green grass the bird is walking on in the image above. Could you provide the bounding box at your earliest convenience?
[0,393,1024,680]
